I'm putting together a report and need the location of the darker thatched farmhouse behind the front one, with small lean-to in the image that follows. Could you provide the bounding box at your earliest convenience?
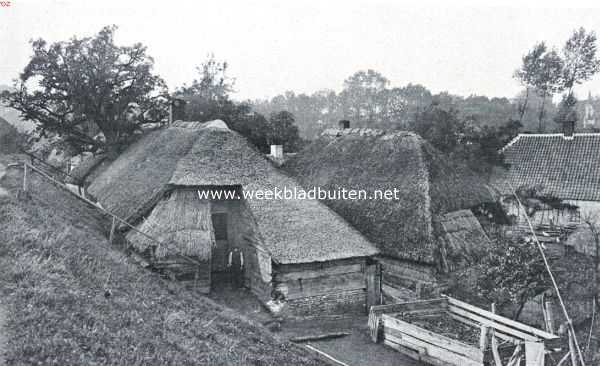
[285,126,493,300]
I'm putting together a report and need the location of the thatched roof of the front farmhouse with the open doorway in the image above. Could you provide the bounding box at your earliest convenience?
[89,122,378,263]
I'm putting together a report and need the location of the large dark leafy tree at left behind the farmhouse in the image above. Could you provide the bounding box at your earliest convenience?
[3,26,168,152]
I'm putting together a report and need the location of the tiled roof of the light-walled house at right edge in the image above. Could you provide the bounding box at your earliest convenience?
[492,133,600,201]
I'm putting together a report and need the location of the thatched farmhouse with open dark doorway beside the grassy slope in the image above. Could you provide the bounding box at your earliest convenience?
[88,121,379,316]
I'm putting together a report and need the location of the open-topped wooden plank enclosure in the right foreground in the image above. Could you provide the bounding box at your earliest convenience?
[369,297,560,366]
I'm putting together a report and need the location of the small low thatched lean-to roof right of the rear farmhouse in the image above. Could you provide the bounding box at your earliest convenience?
[434,210,492,271]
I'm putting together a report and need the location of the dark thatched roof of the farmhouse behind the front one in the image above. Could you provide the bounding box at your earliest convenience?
[284,129,494,263]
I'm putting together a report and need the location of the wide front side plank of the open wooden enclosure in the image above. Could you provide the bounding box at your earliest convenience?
[382,314,483,362]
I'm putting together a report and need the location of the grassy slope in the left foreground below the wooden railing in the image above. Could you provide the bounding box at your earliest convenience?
[0,157,324,365]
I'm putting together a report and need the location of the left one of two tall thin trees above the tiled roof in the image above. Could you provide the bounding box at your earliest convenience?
[515,42,563,132]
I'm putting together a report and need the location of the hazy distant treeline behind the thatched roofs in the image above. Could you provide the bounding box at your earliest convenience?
[252,70,559,139]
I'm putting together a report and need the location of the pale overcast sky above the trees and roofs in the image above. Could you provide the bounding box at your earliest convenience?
[0,0,600,99]
